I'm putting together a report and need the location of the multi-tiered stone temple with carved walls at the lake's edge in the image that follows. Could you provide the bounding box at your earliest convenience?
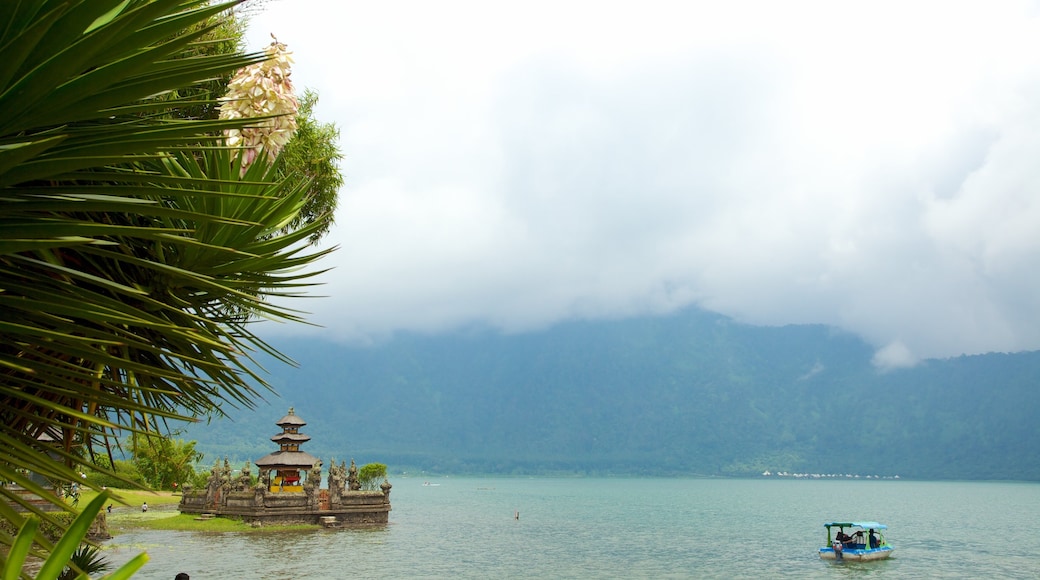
[179,407,391,527]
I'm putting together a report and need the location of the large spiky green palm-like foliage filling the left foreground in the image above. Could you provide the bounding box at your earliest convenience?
[0,0,328,557]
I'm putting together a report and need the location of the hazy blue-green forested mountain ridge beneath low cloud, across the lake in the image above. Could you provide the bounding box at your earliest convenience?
[187,309,1040,480]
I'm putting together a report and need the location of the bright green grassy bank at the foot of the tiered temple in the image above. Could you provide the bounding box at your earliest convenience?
[86,490,319,535]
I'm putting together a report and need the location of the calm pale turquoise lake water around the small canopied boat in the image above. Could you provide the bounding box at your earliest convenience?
[106,477,1040,580]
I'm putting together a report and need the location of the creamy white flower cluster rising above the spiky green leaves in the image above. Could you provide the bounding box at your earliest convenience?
[220,39,300,172]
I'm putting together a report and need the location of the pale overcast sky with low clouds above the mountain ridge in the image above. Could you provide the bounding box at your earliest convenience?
[241,0,1040,365]
